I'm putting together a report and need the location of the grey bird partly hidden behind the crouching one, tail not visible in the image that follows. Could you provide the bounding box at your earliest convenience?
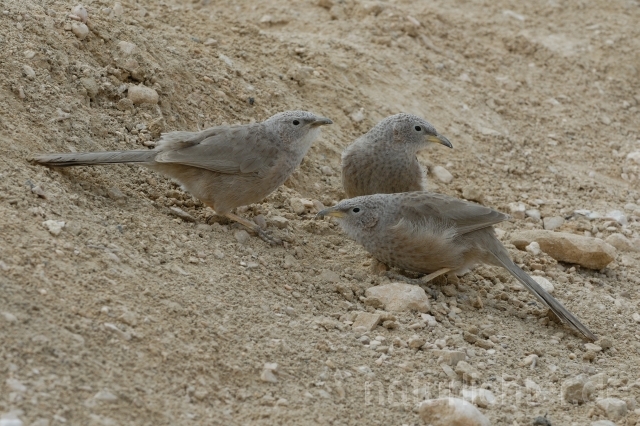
[342,113,453,198]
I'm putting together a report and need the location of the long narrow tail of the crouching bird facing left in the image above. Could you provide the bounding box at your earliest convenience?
[491,247,598,341]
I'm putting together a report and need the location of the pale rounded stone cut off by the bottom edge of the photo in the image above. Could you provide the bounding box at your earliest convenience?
[418,398,491,426]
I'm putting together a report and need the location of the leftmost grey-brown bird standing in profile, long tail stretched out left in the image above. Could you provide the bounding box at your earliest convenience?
[31,111,332,243]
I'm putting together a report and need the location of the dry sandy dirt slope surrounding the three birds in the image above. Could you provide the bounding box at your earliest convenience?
[0,0,640,426]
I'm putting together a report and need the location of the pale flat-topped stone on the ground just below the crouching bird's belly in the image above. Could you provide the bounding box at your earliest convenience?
[365,283,431,312]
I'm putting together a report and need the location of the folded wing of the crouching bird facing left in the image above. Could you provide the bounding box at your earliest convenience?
[400,192,509,235]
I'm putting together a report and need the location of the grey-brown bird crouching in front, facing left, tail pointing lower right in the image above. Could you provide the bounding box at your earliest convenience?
[318,191,597,341]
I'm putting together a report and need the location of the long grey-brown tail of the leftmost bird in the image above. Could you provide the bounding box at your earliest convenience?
[31,150,158,167]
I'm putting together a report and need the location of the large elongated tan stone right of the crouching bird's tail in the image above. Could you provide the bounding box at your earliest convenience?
[511,230,616,270]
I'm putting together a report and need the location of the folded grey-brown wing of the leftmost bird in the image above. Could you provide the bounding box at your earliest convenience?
[155,125,278,174]
